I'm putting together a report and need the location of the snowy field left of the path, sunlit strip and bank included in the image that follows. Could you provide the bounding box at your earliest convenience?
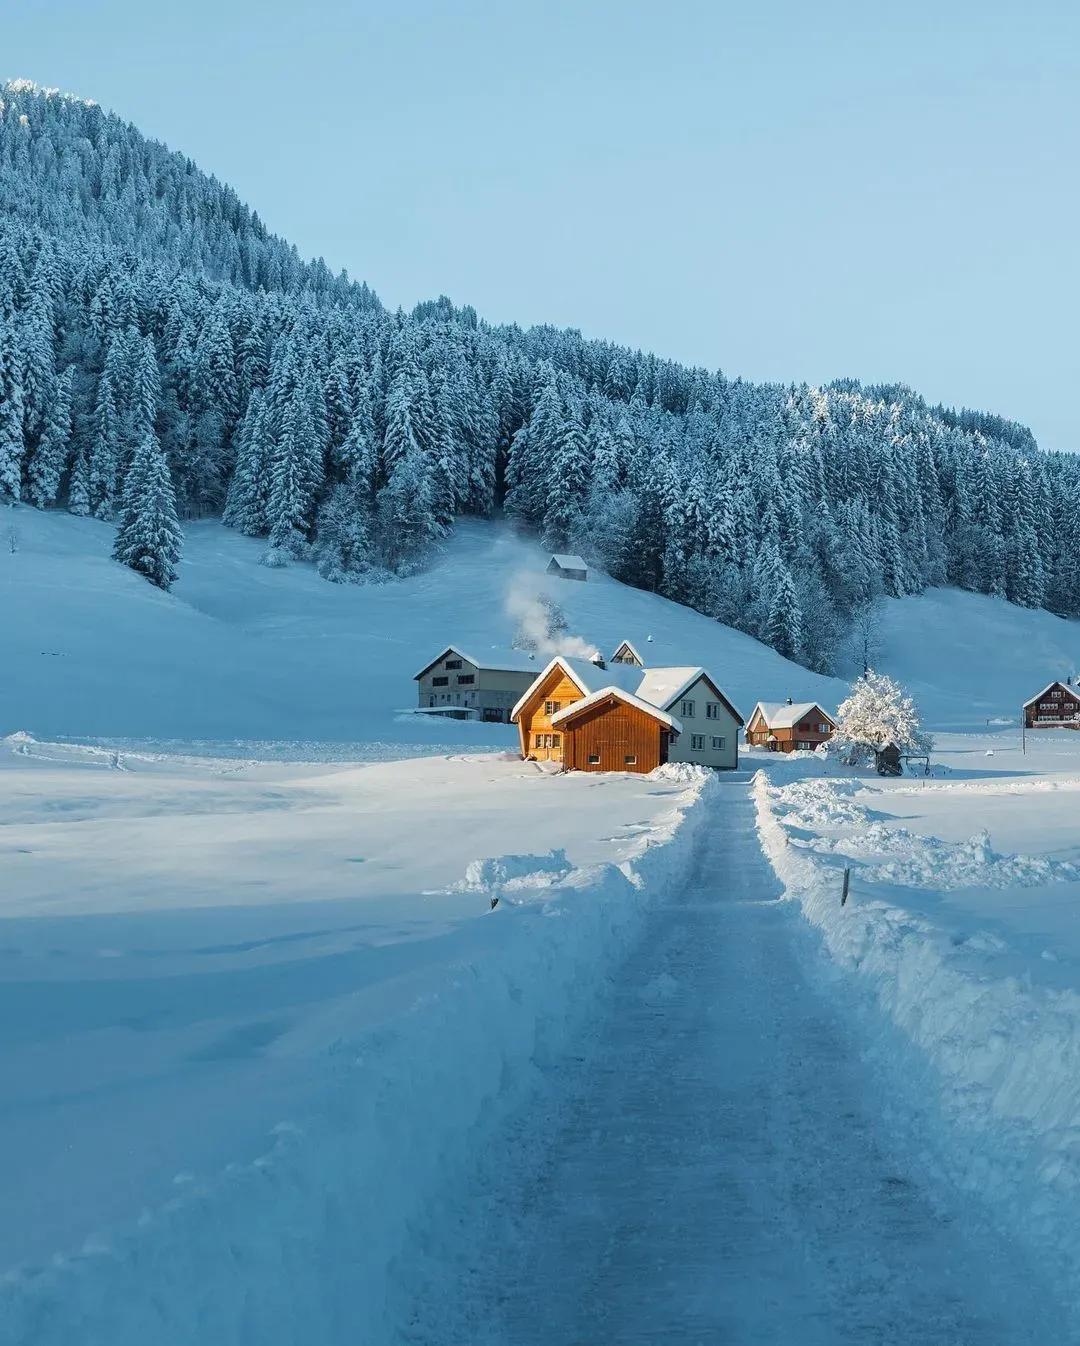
[0,739,707,1343]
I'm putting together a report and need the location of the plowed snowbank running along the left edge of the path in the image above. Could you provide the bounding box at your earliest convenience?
[0,770,712,1346]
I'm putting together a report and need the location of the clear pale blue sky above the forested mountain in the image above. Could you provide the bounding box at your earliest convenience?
[0,0,1080,450]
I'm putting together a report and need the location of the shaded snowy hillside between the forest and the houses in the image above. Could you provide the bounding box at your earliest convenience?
[0,509,1080,756]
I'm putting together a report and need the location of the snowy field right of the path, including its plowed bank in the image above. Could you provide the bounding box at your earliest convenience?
[754,731,1080,1319]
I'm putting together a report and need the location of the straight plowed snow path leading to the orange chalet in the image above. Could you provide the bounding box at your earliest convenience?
[411,782,1068,1346]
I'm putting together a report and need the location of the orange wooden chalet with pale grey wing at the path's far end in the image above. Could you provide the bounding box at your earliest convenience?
[510,656,742,773]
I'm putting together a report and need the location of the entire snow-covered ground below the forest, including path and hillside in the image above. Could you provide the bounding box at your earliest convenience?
[0,509,1080,1346]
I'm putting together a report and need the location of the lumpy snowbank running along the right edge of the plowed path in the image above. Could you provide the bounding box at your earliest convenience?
[753,771,1080,1299]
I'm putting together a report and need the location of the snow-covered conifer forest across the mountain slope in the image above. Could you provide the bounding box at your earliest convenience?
[0,81,1080,669]
